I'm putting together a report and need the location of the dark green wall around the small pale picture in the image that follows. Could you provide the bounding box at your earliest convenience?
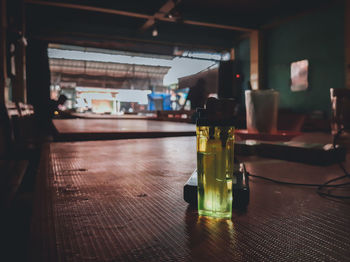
[264,3,345,115]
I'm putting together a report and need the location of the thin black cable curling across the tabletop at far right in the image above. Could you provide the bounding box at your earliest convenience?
[247,129,350,199]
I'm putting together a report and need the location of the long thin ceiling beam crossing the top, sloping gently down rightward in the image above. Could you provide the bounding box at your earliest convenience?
[24,0,254,32]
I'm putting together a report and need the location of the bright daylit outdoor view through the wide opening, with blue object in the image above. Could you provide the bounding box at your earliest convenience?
[48,44,230,118]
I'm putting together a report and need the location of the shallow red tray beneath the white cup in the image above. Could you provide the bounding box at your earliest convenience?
[235,129,302,141]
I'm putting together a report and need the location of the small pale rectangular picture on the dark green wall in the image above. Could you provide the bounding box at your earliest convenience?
[290,59,309,92]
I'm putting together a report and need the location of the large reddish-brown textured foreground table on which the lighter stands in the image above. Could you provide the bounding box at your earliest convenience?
[30,134,350,261]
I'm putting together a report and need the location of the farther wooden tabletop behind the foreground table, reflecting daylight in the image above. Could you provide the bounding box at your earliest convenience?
[53,119,196,141]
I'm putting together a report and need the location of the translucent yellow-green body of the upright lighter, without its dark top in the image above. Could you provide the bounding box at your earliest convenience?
[197,126,234,218]
